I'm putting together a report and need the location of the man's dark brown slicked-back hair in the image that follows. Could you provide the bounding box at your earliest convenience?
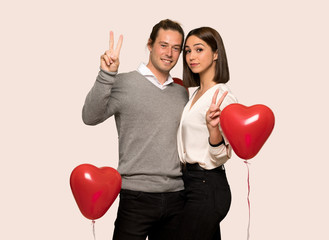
[148,19,184,48]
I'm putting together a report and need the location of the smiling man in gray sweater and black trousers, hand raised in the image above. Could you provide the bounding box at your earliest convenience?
[83,19,188,240]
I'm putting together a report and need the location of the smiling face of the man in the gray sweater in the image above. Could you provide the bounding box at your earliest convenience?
[148,29,182,74]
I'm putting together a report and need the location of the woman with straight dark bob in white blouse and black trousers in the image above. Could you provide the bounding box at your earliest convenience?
[177,27,237,240]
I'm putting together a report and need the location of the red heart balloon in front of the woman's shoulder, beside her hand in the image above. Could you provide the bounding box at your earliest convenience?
[220,103,274,159]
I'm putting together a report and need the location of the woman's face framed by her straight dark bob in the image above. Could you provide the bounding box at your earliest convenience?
[184,35,217,74]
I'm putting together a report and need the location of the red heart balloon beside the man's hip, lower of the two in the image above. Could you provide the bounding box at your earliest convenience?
[70,164,121,220]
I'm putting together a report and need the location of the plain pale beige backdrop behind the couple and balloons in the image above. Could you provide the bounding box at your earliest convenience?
[0,0,329,240]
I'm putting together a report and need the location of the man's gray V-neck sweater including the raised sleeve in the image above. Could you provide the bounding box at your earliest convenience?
[82,71,188,192]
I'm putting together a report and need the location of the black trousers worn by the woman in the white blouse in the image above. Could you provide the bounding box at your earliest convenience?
[176,164,231,240]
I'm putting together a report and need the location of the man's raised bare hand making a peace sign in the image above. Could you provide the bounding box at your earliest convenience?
[101,31,123,72]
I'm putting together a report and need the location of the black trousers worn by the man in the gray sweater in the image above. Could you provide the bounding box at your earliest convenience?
[113,189,184,240]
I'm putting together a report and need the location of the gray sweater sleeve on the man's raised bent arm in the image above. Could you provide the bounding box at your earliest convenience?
[82,70,118,125]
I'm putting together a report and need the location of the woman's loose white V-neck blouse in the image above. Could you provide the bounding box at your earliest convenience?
[177,83,237,170]
